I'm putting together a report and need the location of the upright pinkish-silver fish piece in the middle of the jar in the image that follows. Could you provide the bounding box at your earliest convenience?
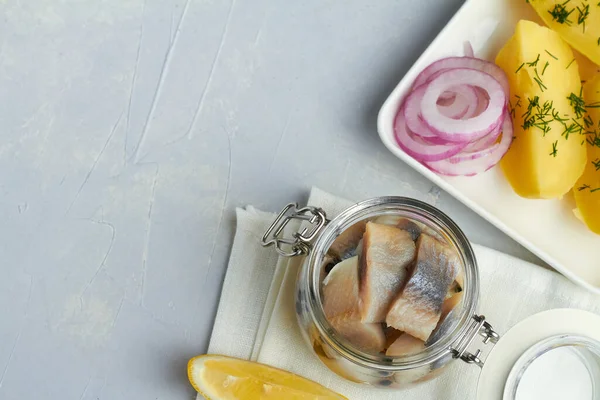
[358,222,415,323]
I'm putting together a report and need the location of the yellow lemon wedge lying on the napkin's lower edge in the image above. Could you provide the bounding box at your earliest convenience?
[187,354,347,400]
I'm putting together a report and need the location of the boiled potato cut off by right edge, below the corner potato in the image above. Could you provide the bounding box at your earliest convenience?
[573,75,600,234]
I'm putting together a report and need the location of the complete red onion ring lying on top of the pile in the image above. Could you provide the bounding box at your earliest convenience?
[420,68,506,142]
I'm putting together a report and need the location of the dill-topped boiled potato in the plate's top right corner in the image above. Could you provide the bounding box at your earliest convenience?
[529,0,600,65]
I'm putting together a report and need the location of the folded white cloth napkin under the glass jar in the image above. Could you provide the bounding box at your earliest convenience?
[205,189,600,400]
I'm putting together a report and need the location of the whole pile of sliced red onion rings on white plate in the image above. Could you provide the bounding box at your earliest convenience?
[394,53,513,176]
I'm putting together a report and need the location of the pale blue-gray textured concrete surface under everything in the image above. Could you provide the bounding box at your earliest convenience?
[0,0,536,400]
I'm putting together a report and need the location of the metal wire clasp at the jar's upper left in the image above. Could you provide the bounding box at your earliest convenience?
[261,203,328,257]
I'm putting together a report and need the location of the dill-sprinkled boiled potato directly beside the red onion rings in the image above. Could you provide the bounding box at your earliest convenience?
[496,21,586,199]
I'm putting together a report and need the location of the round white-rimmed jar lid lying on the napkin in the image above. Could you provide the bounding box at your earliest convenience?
[477,309,600,400]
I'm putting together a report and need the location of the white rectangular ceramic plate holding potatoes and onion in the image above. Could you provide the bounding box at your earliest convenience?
[377,0,600,293]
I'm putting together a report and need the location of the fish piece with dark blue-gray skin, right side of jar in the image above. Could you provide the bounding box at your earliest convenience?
[386,234,460,341]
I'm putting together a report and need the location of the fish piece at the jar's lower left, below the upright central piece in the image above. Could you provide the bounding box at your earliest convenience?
[329,312,385,353]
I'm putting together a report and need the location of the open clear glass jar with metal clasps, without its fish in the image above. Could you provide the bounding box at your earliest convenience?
[262,197,499,388]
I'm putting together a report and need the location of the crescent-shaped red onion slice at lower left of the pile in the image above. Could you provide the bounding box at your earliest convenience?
[394,111,467,162]
